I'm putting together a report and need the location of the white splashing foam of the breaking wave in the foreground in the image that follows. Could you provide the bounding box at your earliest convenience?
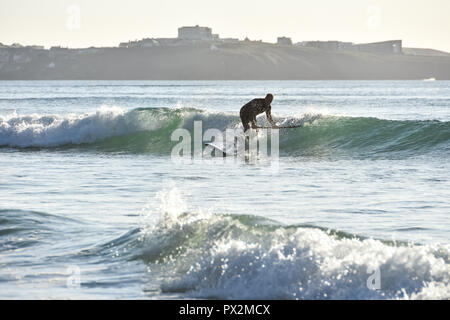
[142,190,450,299]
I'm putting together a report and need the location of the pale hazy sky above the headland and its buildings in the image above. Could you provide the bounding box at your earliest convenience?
[0,0,450,51]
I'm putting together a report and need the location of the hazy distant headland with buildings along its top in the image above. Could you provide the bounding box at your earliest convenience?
[0,26,450,80]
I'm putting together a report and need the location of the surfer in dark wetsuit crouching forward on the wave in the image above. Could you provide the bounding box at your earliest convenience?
[240,93,278,132]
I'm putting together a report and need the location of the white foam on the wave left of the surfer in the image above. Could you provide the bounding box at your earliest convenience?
[0,106,239,147]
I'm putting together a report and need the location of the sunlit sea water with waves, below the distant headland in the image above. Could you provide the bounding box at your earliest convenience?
[0,81,450,299]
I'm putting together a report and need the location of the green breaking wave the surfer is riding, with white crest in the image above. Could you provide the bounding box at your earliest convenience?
[0,107,450,156]
